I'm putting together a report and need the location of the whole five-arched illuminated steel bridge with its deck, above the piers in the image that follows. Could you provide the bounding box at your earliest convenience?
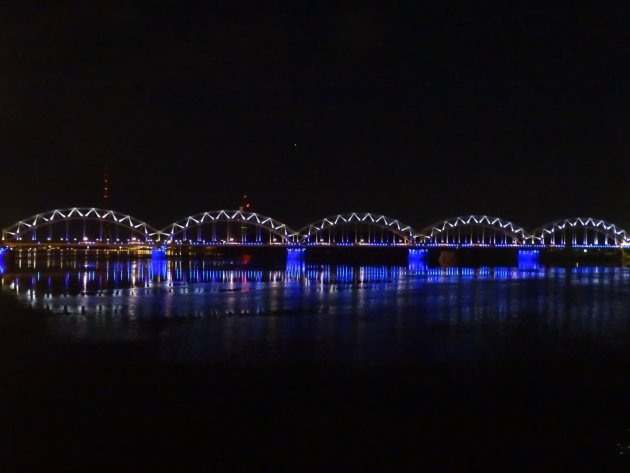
[0,207,630,252]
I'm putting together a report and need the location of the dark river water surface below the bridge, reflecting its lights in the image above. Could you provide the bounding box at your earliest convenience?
[0,254,630,471]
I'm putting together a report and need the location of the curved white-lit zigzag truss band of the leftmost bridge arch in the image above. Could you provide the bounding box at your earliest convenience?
[2,207,159,241]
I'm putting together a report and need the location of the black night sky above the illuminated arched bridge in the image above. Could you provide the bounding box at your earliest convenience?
[0,0,630,227]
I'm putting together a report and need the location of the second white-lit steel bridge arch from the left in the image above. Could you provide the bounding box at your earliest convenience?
[160,210,299,245]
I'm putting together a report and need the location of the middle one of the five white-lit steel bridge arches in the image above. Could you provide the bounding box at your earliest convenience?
[300,212,417,245]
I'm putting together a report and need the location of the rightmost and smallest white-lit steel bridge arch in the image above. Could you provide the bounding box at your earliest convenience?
[532,217,630,247]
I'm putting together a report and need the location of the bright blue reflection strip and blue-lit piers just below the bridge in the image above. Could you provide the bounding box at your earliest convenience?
[0,252,626,292]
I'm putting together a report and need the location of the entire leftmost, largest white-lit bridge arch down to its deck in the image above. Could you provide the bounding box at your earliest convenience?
[2,207,159,244]
